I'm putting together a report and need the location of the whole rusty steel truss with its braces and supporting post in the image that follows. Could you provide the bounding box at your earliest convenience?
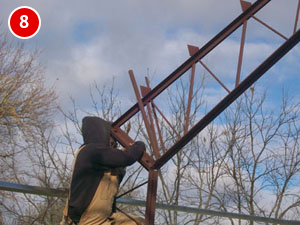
[108,0,300,225]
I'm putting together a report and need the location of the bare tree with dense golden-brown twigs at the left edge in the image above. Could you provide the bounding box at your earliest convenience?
[0,31,56,224]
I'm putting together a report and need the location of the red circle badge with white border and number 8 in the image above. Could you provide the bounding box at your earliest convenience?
[8,6,41,39]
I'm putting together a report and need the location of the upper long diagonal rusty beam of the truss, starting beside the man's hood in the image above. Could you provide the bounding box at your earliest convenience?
[113,0,271,127]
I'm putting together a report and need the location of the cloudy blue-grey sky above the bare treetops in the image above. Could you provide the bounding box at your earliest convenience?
[0,0,300,119]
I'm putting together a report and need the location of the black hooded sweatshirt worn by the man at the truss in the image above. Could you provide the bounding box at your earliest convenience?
[68,117,145,222]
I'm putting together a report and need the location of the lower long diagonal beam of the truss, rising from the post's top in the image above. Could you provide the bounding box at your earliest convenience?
[152,30,300,169]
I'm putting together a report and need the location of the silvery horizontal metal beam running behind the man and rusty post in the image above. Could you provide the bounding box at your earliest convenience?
[0,181,300,225]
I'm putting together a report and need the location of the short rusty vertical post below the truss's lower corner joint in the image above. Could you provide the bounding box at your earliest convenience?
[145,170,158,225]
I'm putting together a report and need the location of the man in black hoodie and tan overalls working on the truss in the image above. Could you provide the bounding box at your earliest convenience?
[61,117,145,225]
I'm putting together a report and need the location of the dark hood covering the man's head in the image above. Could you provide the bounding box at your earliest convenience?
[81,116,111,147]
